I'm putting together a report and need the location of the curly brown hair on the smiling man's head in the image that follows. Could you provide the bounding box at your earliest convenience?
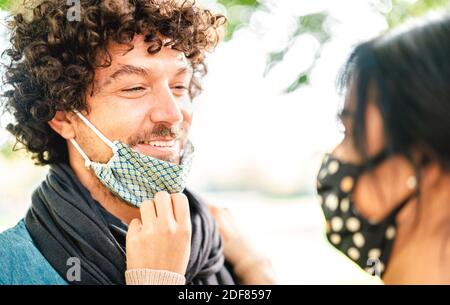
[3,0,226,165]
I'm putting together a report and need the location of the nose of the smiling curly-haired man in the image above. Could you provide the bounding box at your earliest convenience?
[150,87,183,125]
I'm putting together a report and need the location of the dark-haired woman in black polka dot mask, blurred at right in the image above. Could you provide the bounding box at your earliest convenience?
[213,11,450,284]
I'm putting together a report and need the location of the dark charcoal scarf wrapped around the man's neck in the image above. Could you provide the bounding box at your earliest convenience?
[25,164,235,284]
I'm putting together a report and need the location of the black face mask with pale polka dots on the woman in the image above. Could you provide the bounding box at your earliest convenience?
[317,152,417,277]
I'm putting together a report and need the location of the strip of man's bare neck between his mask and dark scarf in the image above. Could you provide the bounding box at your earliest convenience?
[70,159,140,224]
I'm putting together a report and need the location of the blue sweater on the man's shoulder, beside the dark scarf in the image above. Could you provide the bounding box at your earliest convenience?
[0,219,68,285]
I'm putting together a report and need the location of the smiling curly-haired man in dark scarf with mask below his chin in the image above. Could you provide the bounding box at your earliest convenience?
[0,0,243,284]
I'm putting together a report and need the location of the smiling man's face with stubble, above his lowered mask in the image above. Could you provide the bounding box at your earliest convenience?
[75,35,192,163]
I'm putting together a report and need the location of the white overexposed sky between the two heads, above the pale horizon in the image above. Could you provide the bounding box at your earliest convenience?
[191,0,387,194]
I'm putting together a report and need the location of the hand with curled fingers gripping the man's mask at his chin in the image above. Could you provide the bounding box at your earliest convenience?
[126,192,192,275]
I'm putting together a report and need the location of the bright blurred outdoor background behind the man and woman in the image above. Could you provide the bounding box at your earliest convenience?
[0,0,450,284]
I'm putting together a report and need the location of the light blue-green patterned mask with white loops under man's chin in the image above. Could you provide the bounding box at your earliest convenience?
[70,111,194,207]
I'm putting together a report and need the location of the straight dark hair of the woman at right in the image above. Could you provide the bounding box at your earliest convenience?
[338,16,450,170]
